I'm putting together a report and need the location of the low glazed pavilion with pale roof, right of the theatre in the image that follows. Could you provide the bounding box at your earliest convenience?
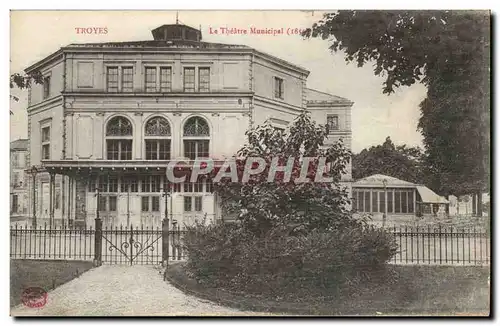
[352,174,449,222]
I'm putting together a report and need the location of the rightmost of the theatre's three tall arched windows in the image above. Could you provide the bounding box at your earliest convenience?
[183,117,210,160]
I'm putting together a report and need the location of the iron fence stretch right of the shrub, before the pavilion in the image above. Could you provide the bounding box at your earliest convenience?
[388,226,491,265]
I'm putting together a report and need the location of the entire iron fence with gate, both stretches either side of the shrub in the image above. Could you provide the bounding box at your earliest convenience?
[10,219,491,265]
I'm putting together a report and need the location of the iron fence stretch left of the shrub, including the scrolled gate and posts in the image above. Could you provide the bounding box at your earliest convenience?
[10,220,186,265]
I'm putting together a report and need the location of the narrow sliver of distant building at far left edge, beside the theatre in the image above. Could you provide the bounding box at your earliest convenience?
[10,139,29,216]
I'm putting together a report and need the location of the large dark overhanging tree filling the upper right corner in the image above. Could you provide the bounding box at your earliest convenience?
[303,10,490,214]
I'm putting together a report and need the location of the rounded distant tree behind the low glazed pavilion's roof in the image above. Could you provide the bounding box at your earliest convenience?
[352,137,425,183]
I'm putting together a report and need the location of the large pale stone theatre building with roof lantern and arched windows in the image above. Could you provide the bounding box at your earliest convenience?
[25,24,353,226]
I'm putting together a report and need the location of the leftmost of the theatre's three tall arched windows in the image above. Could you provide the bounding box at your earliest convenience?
[106,117,132,160]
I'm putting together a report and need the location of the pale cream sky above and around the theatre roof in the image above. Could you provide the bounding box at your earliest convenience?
[10,11,426,153]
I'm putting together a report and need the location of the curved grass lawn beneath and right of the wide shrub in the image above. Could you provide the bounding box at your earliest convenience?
[167,264,490,316]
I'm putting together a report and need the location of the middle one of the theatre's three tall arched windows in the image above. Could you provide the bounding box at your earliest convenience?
[144,117,171,160]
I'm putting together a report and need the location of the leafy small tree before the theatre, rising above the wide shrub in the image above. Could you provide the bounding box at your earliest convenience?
[215,112,355,235]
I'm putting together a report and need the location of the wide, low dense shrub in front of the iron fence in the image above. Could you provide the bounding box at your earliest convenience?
[184,224,396,296]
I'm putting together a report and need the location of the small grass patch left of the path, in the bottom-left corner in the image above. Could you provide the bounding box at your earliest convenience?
[10,259,93,307]
